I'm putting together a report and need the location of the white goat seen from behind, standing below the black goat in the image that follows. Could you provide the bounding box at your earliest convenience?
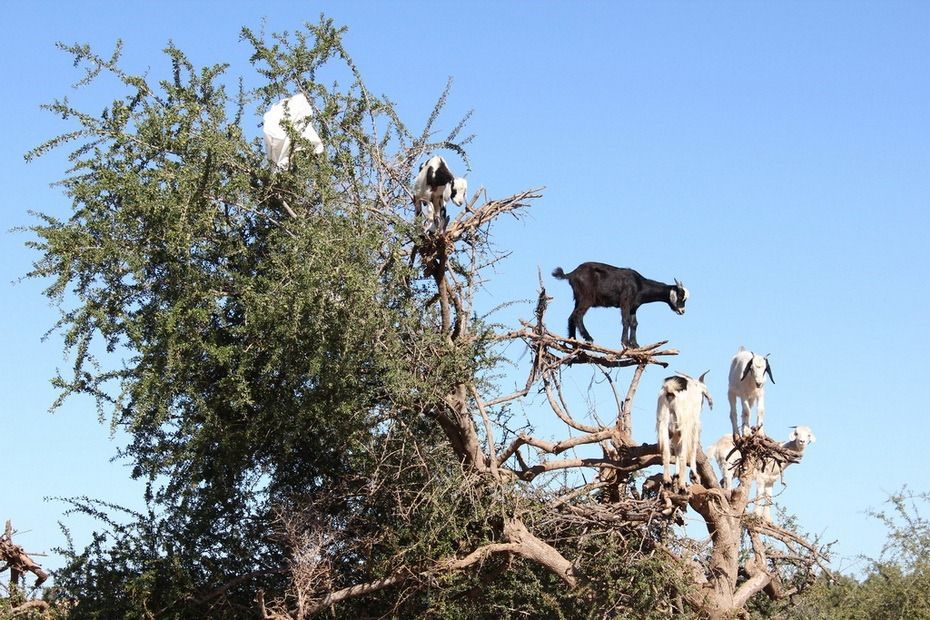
[656,372,714,488]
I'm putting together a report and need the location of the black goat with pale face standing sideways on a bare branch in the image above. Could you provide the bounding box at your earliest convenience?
[552,263,688,349]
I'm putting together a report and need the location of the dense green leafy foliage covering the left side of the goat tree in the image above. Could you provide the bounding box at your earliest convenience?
[27,19,488,618]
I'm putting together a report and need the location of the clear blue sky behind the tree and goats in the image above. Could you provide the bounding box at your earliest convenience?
[0,1,930,570]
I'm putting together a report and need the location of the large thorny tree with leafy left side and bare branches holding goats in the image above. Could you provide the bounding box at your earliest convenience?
[29,19,819,618]
